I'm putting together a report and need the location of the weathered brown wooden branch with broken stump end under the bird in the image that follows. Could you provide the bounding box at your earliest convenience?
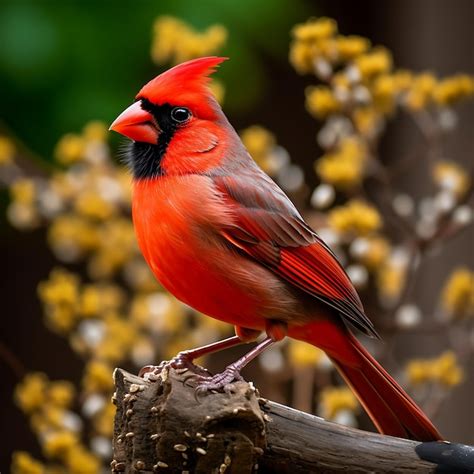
[111,369,474,474]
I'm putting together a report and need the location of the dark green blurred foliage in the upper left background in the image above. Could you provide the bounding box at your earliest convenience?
[0,0,307,159]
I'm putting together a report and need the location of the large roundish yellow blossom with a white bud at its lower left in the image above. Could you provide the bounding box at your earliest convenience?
[315,137,367,190]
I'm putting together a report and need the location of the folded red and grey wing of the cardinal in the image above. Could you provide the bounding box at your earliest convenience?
[214,170,378,337]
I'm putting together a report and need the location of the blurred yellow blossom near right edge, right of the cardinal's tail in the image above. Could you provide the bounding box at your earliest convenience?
[406,351,464,387]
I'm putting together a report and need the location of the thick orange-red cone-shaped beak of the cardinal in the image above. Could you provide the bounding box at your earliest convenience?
[109,101,160,145]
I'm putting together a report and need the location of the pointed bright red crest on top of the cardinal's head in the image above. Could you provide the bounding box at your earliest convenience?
[136,56,228,113]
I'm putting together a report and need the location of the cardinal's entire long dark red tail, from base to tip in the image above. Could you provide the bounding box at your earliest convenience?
[290,322,443,441]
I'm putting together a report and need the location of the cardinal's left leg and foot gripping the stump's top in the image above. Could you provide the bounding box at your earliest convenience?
[138,327,260,379]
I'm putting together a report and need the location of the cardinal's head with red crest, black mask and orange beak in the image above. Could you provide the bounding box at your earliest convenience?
[110,57,231,179]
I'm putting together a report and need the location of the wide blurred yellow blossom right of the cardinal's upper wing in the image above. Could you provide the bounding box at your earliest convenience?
[328,199,382,235]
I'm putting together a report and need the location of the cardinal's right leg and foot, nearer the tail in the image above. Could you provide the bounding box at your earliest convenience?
[188,321,287,396]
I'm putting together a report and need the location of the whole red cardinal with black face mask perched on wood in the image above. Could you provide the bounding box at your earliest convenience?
[110,57,441,441]
